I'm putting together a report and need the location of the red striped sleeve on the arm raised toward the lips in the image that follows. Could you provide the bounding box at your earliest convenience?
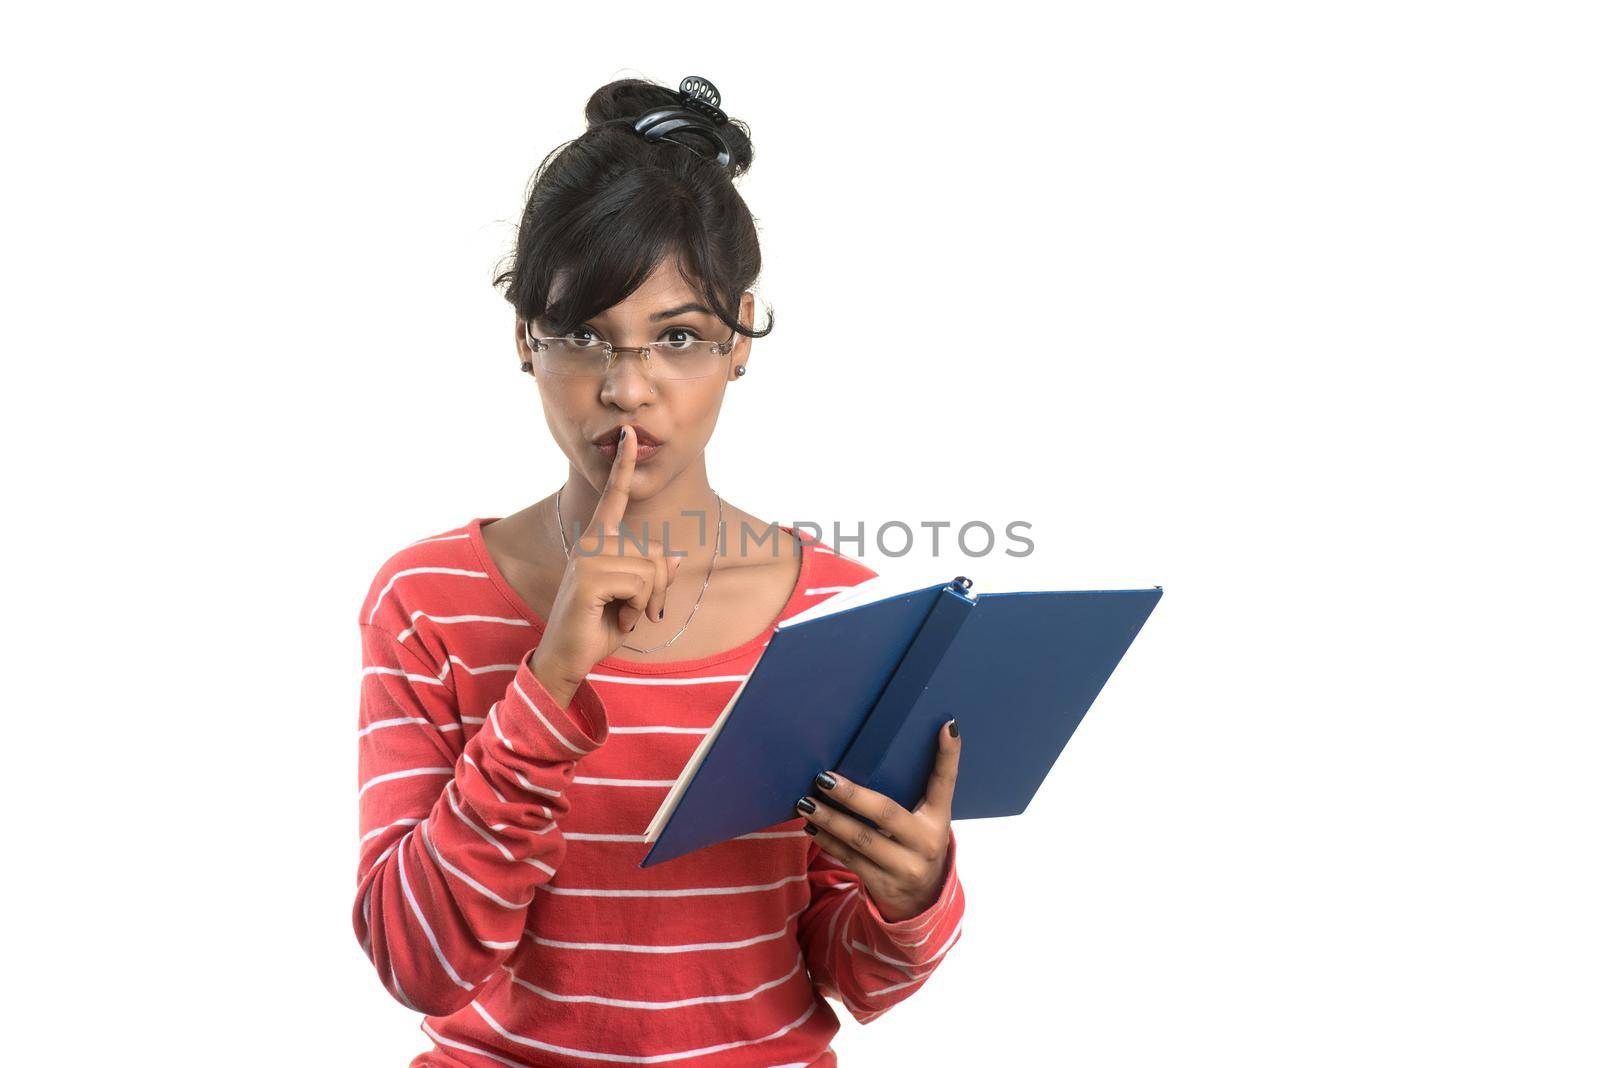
[352,624,610,1015]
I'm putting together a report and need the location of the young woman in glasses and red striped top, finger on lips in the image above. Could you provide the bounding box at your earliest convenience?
[354,78,965,1068]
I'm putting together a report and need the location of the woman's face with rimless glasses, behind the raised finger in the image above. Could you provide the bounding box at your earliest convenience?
[517,259,755,500]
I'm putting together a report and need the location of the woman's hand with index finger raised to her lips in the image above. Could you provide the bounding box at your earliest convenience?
[531,427,683,708]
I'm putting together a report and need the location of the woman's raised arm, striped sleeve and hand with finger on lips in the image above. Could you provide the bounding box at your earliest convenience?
[354,427,683,1015]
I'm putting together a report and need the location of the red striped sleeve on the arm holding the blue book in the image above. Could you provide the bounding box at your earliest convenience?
[800,828,966,1023]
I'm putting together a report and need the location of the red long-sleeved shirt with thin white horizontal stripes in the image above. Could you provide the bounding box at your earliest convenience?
[354,518,965,1068]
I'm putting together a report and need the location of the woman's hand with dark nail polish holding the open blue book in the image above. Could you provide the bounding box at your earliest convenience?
[795,719,962,923]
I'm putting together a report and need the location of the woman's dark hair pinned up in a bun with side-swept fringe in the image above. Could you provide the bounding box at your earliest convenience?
[493,78,773,341]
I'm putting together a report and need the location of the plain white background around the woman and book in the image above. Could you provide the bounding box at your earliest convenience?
[0,3,1600,1068]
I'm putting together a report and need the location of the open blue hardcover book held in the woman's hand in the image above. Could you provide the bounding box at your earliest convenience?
[640,577,1162,868]
